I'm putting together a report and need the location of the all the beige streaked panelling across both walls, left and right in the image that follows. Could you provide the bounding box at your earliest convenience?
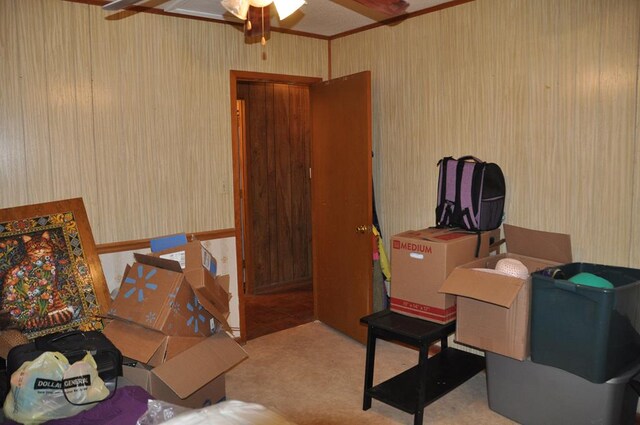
[0,0,640,267]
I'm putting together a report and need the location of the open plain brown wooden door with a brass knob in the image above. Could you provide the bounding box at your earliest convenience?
[310,71,373,343]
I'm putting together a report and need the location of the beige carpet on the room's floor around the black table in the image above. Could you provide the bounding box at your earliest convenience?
[227,322,514,425]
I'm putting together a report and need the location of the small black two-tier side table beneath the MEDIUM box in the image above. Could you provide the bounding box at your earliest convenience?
[360,310,485,425]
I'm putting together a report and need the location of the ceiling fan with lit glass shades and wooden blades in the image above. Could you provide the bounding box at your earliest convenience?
[102,0,409,45]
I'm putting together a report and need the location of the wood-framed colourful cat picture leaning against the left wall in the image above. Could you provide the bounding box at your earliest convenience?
[0,198,111,339]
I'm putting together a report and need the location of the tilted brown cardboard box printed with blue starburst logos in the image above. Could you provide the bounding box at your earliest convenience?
[109,254,213,336]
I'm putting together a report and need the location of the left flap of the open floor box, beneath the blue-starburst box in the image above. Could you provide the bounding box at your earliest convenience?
[103,318,167,363]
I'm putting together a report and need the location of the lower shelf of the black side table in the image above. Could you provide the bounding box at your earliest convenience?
[365,347,485,415]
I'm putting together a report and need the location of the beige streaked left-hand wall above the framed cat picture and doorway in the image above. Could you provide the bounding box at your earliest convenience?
[0,0,328,243]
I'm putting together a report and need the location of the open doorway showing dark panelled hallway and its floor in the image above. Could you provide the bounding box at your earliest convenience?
[231,71,320,340]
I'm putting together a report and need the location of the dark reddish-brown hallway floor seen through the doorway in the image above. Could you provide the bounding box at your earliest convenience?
[244,287,313,340]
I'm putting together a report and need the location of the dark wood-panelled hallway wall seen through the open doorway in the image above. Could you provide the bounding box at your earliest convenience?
[237,81,311,294]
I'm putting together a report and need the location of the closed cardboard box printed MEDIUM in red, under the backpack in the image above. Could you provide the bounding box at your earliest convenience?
[391,228,499,323]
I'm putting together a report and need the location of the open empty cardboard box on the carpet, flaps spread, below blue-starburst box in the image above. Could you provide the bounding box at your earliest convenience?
[104,319,247,407]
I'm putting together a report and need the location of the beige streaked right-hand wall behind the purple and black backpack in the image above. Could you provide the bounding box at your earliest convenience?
[331,0,640,267]
